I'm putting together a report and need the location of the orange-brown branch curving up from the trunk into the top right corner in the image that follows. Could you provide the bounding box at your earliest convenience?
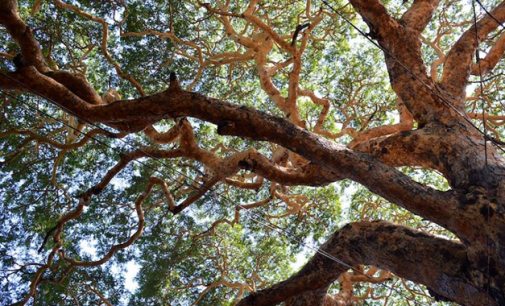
[440,1,505,98]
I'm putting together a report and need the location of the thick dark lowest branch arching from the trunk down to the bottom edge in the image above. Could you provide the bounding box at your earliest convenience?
[238,221,488,306]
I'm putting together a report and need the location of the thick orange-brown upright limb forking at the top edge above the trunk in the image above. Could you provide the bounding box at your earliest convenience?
[350,0,454,125]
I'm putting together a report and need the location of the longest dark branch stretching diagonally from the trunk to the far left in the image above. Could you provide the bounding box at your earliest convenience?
[4,67,476,239]
